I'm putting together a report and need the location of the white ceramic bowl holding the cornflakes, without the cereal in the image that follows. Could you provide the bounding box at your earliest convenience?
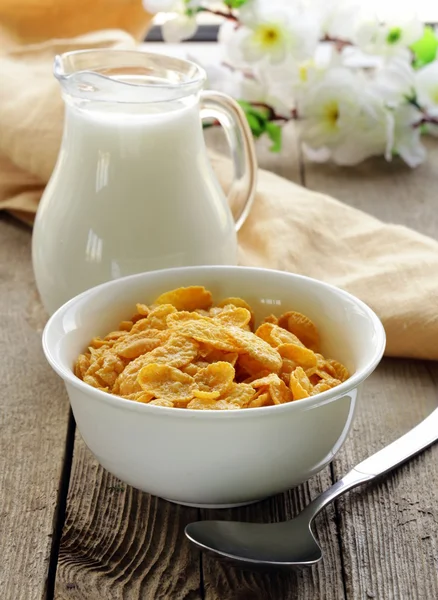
[43,266,385,508]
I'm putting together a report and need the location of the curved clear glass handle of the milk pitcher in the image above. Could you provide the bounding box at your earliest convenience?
[201,91,257,231]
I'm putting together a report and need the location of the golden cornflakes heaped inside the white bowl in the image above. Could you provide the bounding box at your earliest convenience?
[75,286,349,410]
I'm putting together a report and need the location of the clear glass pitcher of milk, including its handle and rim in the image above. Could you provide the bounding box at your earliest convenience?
[32,49,257,314]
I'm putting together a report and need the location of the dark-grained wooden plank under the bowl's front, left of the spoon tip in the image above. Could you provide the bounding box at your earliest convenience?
[55,434,201,600]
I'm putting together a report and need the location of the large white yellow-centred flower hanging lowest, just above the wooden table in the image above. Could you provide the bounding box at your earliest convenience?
[298,68,393,165]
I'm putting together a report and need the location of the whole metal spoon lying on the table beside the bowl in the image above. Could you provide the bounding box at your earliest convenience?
[185,409,438,569]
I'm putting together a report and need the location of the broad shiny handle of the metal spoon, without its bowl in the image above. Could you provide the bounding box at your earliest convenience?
[303,408,438,519]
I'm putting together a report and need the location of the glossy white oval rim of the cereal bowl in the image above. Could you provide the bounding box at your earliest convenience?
[42,265,386,419]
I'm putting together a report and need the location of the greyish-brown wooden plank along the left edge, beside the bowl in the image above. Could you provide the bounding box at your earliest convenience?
[0,216,69,600]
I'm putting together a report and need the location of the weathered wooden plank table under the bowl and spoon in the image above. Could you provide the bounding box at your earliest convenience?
[0,123,438,600]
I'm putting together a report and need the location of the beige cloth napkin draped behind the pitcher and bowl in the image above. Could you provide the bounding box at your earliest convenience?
[0,31,438,359]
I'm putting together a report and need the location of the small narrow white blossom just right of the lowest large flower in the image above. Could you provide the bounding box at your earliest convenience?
[387,104,426,168]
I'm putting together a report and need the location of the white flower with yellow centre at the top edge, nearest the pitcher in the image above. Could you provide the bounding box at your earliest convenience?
[221,1,319,64]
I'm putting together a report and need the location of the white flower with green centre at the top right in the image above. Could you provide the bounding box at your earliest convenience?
[355,15,424,60]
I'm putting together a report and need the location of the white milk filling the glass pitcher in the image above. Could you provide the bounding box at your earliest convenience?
[33,100,237,313]
